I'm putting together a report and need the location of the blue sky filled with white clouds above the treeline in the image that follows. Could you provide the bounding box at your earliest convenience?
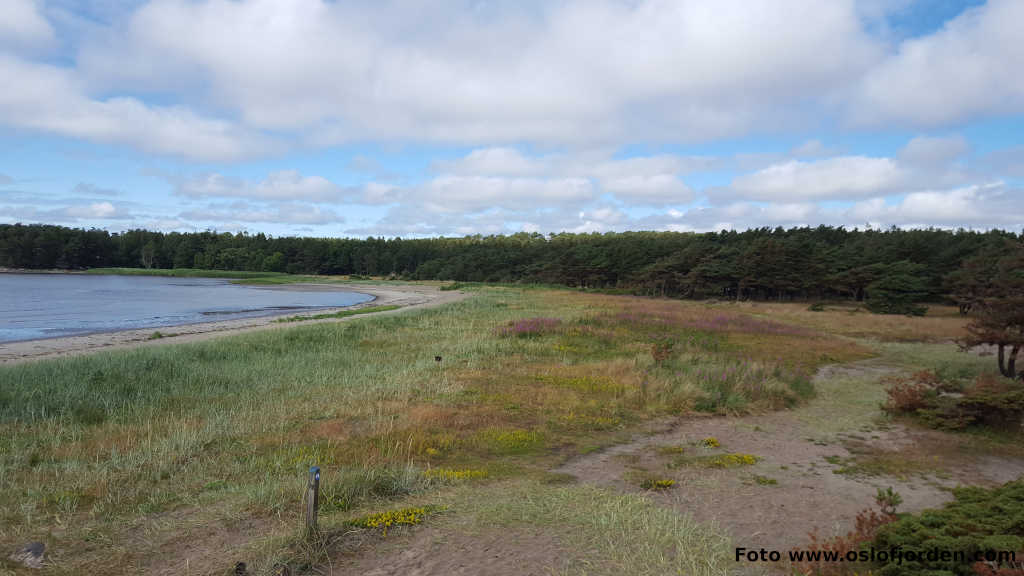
[0,0,1024,238]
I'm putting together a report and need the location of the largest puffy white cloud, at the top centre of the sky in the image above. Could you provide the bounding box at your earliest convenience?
[70,0,881,145]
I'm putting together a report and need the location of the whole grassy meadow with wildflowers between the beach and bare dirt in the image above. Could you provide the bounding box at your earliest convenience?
[0,287,1007,574]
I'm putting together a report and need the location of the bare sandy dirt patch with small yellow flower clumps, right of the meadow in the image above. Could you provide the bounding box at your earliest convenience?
[557,360,1024,569]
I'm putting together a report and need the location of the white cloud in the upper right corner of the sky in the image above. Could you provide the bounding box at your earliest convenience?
[852,0,1024,126]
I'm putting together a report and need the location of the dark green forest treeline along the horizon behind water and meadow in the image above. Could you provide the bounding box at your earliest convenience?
[0,224,1024,300]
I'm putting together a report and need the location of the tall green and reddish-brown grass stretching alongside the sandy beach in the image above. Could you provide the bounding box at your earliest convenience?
[0,288,876,574]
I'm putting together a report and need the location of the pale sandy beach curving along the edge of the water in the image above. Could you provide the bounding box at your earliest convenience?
[0,284,465,364]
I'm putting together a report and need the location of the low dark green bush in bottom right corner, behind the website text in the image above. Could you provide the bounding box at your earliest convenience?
[871,480,1024,576]
